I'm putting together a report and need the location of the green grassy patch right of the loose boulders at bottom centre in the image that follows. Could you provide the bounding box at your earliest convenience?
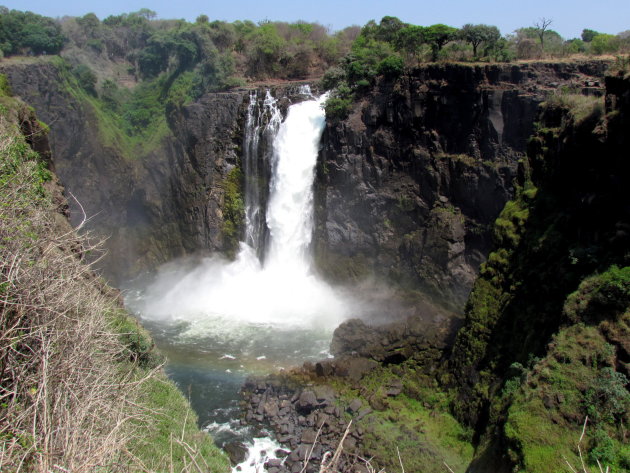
[326,361,474,473]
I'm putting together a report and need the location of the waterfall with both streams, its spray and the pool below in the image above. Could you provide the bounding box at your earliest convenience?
[129,90,350,470]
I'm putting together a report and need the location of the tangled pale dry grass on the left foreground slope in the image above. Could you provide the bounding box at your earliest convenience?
[0,112,147,472]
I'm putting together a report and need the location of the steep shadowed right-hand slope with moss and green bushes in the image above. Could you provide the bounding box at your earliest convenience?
[442,74,630,472]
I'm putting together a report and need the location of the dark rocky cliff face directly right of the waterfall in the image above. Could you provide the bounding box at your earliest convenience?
[315,63,605,307]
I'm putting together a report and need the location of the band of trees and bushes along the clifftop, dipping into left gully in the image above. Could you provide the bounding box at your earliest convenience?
[0,8,630,146]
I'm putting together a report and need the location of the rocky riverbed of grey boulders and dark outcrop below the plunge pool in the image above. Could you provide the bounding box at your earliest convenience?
[228,312,454,473]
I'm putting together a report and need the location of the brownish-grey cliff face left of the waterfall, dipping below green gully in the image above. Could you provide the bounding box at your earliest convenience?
[2,58,246,281]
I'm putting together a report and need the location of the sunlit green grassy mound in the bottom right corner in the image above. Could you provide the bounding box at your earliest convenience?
[504,325,630,473]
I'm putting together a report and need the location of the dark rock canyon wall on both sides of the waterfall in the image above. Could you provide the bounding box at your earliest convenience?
[1,61,606,298]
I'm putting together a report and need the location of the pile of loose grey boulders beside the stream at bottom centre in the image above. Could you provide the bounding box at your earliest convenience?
[242,368,402,473]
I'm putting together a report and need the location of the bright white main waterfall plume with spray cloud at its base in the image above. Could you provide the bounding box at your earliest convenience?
[141,91,349,341]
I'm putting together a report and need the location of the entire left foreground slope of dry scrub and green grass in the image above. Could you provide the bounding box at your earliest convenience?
[0,77,228,472]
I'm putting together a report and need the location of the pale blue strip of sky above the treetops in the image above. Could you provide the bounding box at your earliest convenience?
[0,0,630,38]
